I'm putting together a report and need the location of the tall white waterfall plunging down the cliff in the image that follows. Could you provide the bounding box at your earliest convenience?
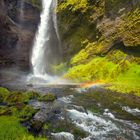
[31,0,60,79]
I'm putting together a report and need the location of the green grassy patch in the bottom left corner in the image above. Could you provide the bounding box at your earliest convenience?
[0,116,46,140]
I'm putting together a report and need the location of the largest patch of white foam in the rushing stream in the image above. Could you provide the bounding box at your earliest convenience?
[67,109,119,136]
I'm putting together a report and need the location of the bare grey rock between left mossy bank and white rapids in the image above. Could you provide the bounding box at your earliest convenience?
[30,101,61,132]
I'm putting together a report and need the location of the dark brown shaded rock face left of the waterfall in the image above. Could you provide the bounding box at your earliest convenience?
[0,0,40,69]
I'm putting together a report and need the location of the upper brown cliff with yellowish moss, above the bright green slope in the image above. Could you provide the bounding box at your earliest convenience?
[58,0,140,59]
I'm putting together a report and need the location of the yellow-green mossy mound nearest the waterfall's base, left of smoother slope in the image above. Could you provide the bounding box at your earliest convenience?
[65,57,116,81]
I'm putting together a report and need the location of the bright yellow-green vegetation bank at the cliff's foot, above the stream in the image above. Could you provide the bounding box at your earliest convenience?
[65,53,140,96]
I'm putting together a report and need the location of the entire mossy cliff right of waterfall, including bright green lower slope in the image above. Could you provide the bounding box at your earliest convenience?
[57,0,140,95]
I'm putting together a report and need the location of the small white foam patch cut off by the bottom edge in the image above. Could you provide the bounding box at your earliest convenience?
[52,132,74,140]
